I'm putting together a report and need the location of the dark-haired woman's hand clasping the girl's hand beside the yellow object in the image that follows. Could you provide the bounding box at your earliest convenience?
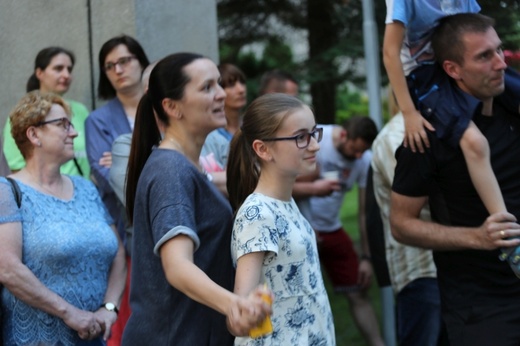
[226,286,273,336]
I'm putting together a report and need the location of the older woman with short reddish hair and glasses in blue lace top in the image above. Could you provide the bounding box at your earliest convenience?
[0,91,126,345]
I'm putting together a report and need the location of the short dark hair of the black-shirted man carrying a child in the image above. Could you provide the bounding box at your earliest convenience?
[432,13,495,65]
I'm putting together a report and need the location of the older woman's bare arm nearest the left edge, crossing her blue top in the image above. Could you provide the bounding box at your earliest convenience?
[0,222,101,339]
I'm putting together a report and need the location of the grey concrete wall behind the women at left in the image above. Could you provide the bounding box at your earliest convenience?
[0,0,218,128]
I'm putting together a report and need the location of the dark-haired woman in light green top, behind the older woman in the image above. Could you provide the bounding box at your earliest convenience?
[3,47,90,178]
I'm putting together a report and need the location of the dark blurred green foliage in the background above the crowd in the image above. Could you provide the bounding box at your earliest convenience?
[217,0,520,123]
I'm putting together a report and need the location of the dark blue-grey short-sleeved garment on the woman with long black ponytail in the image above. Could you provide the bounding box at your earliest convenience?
[123,149,234,346]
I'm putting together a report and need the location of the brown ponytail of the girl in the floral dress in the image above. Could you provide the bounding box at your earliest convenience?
[226,129,260,211]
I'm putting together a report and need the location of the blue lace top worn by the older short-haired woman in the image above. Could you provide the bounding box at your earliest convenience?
[0,176,118,345]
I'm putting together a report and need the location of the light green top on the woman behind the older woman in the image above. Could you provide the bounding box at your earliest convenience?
[3,100,90,178]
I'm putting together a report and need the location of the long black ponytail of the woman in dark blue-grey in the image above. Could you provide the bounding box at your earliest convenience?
[126,94,161,223]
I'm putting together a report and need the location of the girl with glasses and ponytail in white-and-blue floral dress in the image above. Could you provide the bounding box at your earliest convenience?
[227,94,335,345]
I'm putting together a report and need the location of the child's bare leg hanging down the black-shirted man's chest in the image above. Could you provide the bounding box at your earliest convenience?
[460,122,506,214]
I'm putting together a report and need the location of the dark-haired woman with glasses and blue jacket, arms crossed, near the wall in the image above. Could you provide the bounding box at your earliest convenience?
[85,35,149,346]
